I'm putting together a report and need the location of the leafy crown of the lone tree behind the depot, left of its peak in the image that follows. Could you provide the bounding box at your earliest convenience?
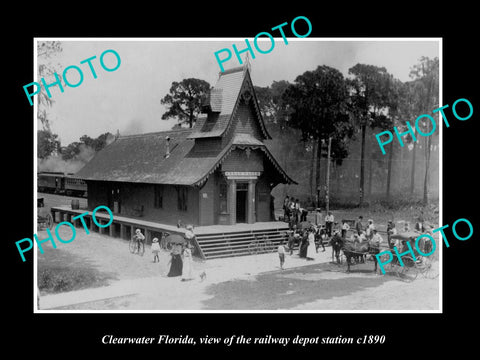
[160,78,210,128]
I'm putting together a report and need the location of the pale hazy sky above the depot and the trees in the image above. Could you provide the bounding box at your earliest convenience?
[35,38,442,146]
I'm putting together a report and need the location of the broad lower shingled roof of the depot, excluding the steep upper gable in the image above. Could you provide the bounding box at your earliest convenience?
[76,129,295,186]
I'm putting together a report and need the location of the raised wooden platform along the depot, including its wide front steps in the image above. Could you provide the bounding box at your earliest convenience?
[51,205,288,259]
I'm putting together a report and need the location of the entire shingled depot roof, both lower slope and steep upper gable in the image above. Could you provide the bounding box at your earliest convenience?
[76,68,295,186]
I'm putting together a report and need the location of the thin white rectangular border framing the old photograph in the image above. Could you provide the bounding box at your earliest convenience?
[33,37,443,314]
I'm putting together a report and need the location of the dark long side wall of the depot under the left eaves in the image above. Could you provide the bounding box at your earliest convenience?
[87,181,199,225]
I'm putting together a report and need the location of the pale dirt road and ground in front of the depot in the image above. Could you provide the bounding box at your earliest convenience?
[38,225,439,311]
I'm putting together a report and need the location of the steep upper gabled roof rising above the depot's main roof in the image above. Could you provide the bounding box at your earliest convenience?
[189,67,271,139]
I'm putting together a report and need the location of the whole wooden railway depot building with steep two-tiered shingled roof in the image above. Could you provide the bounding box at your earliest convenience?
[52,67,295,258]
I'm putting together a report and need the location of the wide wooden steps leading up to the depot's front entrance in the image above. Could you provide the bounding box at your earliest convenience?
[196,229,287,259]
